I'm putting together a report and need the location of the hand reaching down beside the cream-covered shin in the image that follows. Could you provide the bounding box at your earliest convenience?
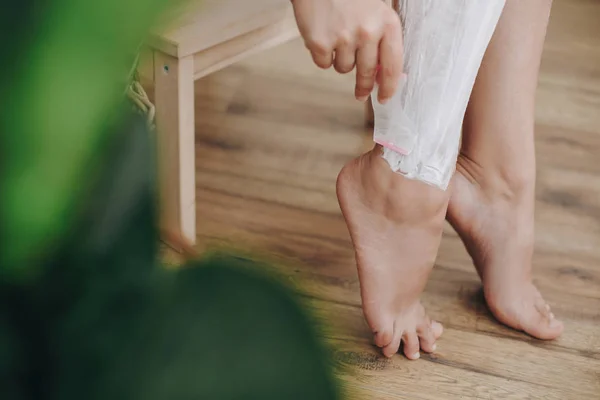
[291,0,403,103]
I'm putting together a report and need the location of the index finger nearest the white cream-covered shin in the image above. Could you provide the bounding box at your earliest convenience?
[377,14,403,104]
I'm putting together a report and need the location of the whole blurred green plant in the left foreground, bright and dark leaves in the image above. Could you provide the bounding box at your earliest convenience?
[0,0,337,400]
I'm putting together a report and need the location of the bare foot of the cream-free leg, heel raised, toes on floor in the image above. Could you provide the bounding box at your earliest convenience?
[447,155,563,339]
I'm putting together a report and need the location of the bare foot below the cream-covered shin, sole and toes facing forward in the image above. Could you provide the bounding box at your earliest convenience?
[337,146,448,360]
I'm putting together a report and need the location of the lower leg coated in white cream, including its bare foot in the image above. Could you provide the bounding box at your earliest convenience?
[337,0,504,359]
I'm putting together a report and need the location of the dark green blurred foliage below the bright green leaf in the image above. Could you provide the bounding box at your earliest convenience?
[0,95,337,400]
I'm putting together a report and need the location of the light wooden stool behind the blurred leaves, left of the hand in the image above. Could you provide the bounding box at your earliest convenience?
[140,0,298,247]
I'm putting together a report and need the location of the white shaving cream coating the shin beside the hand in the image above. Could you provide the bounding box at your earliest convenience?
[373,0,505,190]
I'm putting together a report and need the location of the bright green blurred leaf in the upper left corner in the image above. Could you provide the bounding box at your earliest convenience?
[0,0,178,278]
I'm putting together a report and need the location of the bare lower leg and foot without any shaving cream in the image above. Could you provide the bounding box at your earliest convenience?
[448,0,562,339]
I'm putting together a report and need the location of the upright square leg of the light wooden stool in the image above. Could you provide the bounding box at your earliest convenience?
[154,50,196,244]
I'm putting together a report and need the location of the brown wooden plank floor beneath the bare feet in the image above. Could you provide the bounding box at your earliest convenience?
[162,0,600,400]
